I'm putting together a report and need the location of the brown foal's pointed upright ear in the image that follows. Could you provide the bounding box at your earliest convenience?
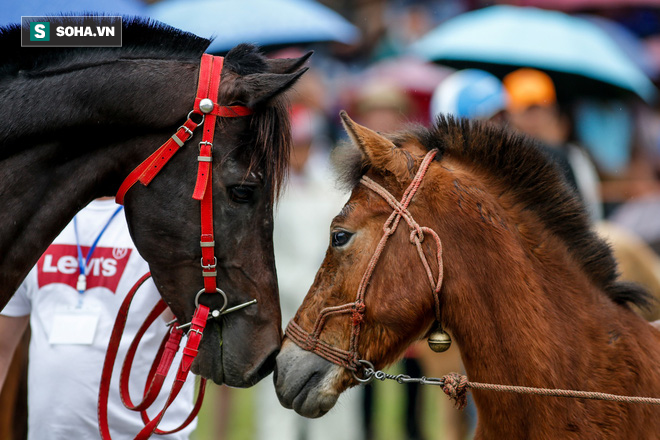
[339,110,410,182]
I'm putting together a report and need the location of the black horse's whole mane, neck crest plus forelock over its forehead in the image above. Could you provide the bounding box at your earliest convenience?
[0,16,291,196]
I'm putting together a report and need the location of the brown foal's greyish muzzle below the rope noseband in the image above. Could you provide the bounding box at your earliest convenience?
[273,340,345,418]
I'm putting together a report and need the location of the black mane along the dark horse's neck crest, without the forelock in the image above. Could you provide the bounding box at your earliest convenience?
[0,16,211,79]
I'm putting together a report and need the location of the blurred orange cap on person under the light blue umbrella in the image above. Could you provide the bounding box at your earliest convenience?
[502,68,557,112]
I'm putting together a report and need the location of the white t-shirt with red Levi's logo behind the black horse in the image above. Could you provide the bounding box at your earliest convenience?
[1,200,196,440]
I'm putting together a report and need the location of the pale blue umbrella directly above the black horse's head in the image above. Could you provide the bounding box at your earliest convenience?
[150,0,359,53]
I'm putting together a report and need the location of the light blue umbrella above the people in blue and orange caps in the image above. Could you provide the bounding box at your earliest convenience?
[412,6,656,101]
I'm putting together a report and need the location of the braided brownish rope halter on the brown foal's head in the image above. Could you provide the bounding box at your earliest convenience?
[286,150,443,380]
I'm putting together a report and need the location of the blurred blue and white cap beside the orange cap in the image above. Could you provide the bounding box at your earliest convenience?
[431,69,508,119]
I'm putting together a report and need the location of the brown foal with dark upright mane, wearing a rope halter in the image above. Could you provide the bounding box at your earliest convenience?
[275,114,660,439]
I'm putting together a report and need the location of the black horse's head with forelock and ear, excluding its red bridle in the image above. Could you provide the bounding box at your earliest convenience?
[125,45,309,387]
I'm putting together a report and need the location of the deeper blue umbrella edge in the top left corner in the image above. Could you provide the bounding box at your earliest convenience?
[0,0,146,26]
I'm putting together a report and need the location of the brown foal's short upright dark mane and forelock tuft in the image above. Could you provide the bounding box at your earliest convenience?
[333,116,650,307]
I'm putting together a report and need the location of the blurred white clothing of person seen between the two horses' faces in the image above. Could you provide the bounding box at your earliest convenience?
[255,145,365,440]
